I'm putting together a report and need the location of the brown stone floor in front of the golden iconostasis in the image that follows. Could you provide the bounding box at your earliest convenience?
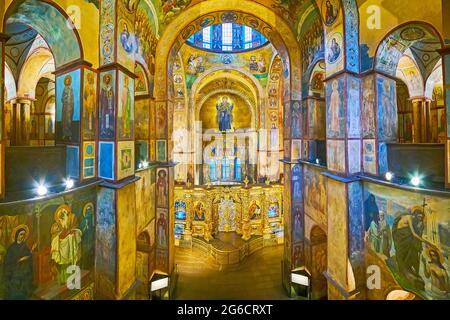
[175,246,288,300]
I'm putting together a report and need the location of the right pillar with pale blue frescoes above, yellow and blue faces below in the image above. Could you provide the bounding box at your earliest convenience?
[324,73,365,299]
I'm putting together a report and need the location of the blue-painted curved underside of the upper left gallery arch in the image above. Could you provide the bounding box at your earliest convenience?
[3,0,84,68]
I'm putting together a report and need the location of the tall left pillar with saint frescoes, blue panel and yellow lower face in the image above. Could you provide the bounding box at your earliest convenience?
[97,0,140,299]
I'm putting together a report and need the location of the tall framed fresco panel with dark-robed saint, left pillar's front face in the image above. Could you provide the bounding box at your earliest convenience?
[99,71,116,139]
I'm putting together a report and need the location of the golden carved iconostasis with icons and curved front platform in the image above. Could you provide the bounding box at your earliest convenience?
[174,184,284,265]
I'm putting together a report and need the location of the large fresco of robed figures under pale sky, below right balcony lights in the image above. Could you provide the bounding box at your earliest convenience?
[364,183,450,299]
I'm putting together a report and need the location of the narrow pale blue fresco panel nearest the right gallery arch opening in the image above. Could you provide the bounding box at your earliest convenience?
[377,76,397,141]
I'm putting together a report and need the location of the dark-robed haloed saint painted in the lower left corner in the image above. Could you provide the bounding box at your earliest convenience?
[1,225,33,300]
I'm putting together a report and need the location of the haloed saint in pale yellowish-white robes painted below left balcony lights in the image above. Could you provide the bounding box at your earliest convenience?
[50,205,82,285]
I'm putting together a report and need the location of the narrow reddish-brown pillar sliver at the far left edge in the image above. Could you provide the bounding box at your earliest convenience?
[0,33,8,198]
